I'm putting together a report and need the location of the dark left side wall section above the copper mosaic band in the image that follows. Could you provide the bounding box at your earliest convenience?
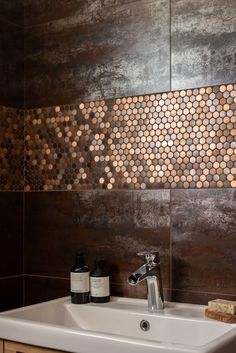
[0,0,24,108]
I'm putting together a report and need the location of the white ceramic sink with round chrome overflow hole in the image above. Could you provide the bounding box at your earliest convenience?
[0,298,236,353]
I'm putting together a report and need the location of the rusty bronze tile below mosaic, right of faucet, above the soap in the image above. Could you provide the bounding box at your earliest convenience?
[171,189,236,296]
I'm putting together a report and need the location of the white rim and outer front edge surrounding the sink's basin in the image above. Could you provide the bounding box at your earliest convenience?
[0,297,236,353]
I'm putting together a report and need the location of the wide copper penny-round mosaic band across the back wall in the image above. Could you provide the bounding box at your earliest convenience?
[25,84,236,191]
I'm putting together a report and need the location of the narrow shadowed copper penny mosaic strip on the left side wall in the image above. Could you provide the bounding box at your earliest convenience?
[0,106,24,191]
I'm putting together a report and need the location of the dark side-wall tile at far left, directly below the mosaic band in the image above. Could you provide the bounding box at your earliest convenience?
[0,192,23,278]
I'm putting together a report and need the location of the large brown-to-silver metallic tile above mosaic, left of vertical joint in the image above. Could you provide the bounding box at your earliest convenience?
[25,0,170,108]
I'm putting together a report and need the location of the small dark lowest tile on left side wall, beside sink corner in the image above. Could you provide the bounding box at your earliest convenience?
[0,276,23,311]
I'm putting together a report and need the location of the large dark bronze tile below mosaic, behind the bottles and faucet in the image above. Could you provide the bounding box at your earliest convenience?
[25,190,170,296]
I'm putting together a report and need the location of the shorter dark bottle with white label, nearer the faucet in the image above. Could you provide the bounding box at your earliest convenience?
[90,259,110,303]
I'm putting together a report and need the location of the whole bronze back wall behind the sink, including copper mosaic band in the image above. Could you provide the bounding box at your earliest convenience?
[0,0,236,304]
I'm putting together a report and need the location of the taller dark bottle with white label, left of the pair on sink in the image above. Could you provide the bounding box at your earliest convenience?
[70,253,89,304]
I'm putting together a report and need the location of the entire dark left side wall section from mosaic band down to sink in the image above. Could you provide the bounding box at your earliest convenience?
[0,192,23,310]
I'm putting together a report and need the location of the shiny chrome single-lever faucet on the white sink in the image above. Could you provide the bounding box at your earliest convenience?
[128,251,164,313]
